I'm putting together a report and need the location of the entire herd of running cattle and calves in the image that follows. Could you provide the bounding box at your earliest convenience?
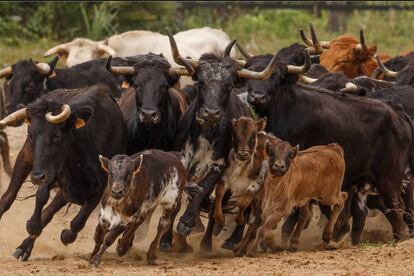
[0,25,414,265]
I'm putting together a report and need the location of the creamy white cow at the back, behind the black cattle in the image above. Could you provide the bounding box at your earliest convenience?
[44,27,235,66]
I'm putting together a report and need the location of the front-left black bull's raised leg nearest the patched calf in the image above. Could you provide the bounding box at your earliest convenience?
[60,193,102,245]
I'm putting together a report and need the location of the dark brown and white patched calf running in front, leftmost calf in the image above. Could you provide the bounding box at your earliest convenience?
[90,150,187,266]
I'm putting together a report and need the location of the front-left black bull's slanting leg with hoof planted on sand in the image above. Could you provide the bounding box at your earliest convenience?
[13,191,67,261]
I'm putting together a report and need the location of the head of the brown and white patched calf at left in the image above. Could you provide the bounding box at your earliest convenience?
[99,154,144,200]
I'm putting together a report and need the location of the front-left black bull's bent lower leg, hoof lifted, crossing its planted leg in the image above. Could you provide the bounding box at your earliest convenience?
[26,184,51,236]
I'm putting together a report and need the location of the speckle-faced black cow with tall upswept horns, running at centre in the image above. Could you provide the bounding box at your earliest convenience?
[169,31,282,250]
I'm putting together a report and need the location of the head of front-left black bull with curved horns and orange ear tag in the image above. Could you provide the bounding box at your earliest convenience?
[0,97,93,184]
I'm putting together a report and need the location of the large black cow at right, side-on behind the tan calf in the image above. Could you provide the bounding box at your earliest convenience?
[246,50,413,244]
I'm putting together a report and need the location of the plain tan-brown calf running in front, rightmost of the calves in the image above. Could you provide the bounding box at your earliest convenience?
[236,132,348,256]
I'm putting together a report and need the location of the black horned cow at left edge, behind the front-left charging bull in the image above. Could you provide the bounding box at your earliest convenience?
[0,56,132,114]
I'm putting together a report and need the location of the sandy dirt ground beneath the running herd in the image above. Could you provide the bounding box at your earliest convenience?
[0,126,414,275]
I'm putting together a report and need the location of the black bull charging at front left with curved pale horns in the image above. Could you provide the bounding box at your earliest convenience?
[0,85,127,261]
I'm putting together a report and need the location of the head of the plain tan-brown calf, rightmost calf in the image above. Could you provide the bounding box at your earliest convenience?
[265,135,299,177]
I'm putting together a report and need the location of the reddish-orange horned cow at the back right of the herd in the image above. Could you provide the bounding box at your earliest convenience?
[302,25,377,78]
